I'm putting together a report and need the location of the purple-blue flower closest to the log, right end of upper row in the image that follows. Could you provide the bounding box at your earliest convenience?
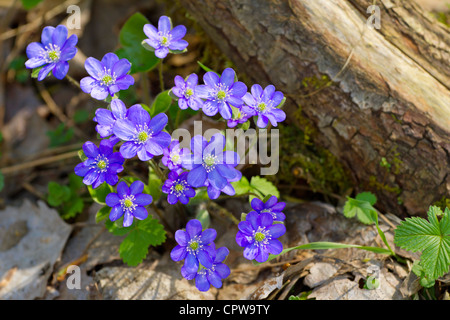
[243,84,286,128]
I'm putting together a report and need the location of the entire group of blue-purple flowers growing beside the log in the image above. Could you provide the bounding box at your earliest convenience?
[25,16,286,291]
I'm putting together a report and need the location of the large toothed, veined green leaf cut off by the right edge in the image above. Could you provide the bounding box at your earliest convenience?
[394,206,450,280]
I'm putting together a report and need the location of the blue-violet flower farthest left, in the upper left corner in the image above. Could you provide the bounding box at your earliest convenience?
[25,25,78,81]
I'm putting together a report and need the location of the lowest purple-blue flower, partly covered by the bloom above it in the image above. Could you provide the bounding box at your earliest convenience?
[181,243,230,292]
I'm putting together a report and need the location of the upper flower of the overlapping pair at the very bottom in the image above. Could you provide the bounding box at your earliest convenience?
[170,219,217,273]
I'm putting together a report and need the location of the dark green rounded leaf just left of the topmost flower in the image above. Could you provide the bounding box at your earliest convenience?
[116,12,160,74]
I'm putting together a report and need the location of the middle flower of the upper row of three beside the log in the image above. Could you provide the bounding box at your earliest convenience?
[195,68,247,120]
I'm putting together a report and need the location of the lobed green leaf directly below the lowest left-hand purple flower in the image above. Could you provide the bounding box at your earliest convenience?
[119,217,166,266]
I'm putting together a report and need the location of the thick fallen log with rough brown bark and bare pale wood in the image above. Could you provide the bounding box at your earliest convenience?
[180,0,450,215]
